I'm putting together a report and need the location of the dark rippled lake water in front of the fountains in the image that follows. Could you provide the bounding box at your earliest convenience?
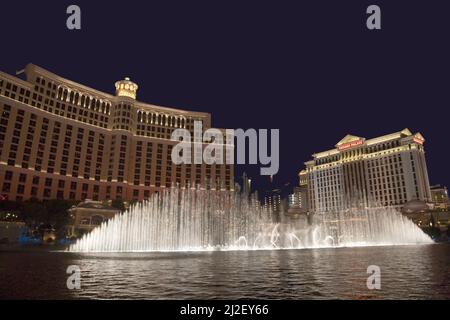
[0,244,450,299]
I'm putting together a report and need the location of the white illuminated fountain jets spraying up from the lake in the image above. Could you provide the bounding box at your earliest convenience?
[69,187,432,252]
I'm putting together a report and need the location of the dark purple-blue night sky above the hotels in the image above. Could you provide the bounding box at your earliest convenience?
[0,0,450,195]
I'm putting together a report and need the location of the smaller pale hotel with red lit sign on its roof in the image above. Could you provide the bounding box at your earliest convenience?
[300,129,432,212]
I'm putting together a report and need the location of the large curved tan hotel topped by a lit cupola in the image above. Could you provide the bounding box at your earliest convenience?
[0,64,234,201]
